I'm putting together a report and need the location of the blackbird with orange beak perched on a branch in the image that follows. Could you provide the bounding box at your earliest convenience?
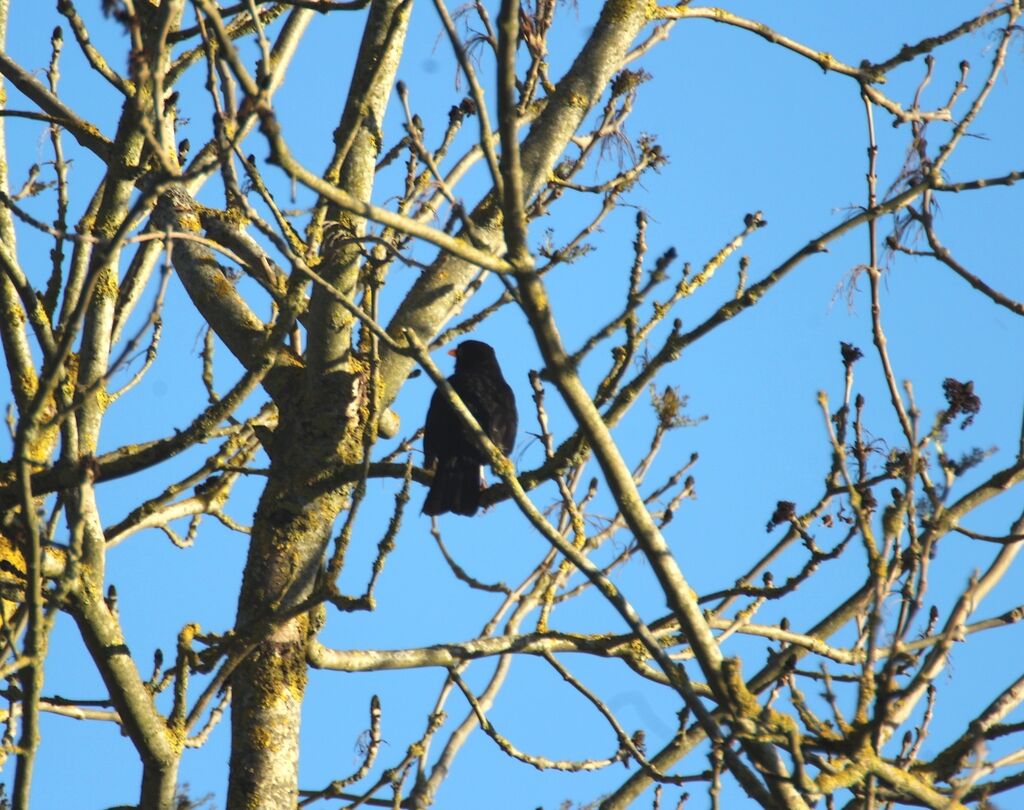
[423,340,519,515]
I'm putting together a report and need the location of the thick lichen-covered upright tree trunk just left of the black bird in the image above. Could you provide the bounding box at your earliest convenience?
[227,0,412,810]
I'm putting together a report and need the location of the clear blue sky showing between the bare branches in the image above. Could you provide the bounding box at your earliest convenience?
[3,0,1024,810]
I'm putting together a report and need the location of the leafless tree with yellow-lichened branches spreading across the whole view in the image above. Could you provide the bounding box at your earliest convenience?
[0,0,1024,810]
